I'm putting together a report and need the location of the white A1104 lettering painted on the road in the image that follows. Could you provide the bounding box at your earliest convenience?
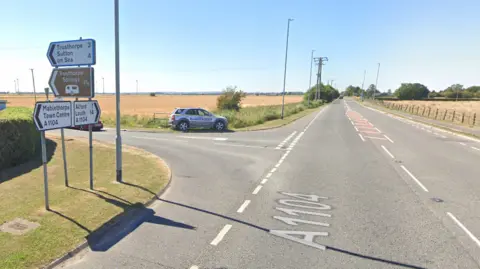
[269,192,332,250]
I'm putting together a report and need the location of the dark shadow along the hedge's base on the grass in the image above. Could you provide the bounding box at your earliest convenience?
[0,139,57,184]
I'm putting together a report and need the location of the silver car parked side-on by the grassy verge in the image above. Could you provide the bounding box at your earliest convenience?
[168,108,228,132]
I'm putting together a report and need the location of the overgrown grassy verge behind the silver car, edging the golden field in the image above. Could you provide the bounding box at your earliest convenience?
[102,102,323,131]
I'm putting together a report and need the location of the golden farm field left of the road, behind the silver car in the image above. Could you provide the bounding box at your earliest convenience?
[0,95,303,116]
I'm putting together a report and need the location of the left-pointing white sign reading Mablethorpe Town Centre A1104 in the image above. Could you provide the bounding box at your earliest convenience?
[33,101,72,131]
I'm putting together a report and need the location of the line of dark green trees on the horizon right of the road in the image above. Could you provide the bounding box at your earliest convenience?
[344,83,480,100]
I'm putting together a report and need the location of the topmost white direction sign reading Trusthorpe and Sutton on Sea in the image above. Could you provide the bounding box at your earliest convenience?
[47,39,96,67]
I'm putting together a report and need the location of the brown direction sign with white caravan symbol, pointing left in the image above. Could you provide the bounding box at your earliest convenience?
[48,67,95,98]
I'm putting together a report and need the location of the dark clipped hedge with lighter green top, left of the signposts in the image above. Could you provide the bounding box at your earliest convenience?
[0,107,40,170]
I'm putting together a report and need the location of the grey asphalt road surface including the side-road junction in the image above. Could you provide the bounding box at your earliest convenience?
[58,100,480,269]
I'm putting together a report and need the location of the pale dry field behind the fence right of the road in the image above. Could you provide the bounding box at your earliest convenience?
[384,101,480,113]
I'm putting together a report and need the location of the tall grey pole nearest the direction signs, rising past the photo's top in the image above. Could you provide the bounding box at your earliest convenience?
[114,0,122,182]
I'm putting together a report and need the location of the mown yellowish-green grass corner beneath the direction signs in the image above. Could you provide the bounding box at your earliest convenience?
[0,138,170,269]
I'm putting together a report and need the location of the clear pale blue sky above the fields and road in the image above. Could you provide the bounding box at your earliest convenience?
[0,0,480,92]
